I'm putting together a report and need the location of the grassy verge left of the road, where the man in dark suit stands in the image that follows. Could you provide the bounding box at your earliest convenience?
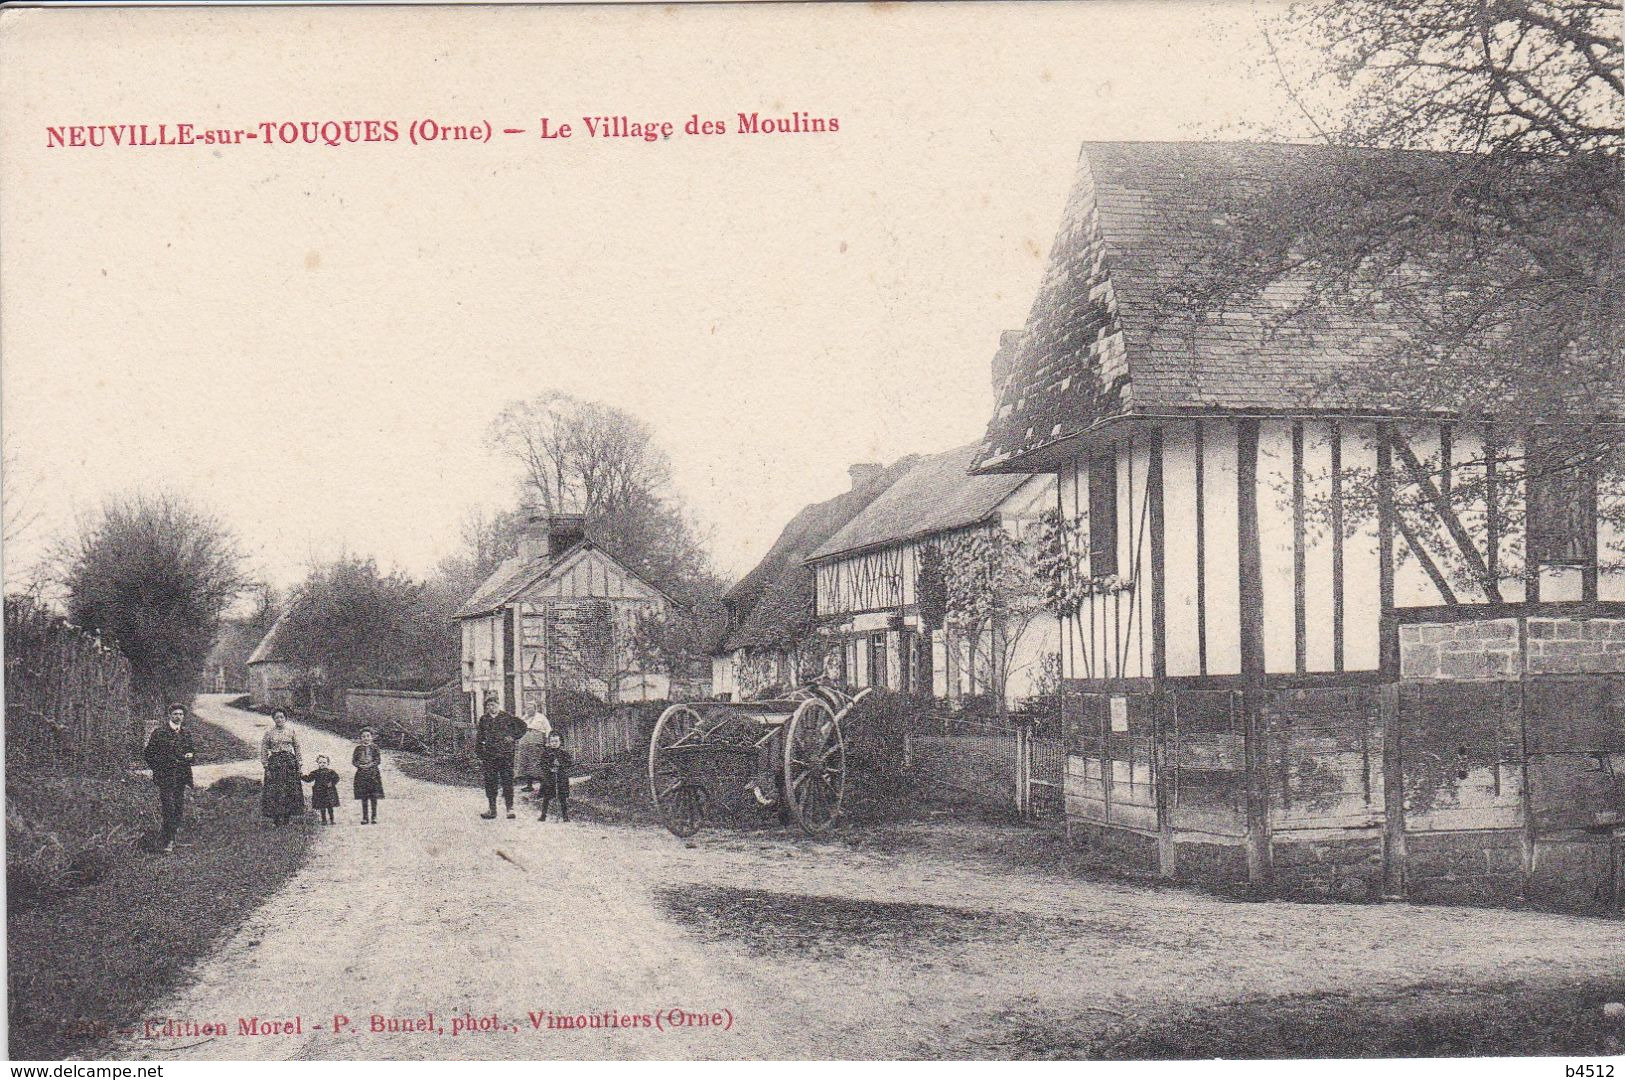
[7,771,315,1059]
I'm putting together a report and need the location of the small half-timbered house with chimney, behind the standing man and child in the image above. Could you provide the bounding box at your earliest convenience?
[455,515,674,715]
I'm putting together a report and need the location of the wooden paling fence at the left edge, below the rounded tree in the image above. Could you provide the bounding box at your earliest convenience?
[5,601,151,771]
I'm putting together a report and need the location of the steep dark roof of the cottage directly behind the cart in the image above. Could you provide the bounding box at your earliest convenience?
[723,456,918,653]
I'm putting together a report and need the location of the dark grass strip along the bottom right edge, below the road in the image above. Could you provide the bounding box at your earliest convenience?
[949,978,1625,1061]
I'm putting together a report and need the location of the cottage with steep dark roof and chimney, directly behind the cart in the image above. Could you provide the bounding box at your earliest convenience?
[712,458,913,698]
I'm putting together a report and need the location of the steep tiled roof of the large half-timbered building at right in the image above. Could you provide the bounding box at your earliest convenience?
[975,143,1625,469]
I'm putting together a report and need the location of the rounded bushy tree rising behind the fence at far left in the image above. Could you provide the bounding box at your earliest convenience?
[55,494,247,698]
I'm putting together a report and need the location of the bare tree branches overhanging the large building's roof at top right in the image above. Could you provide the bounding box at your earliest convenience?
[1209,0,1625,428]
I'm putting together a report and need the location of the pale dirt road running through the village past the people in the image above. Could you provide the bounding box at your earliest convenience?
[107,698,1625,1059]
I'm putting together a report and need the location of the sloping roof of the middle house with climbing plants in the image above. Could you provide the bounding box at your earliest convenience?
[811,443,1027,560]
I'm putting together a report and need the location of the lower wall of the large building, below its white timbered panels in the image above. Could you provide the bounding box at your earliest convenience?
[1068,604,1625,913]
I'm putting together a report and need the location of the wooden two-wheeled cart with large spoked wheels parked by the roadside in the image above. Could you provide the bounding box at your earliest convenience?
[648,679,869,836]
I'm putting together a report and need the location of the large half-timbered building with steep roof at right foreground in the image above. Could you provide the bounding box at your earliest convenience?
[977,143,1625,908]
